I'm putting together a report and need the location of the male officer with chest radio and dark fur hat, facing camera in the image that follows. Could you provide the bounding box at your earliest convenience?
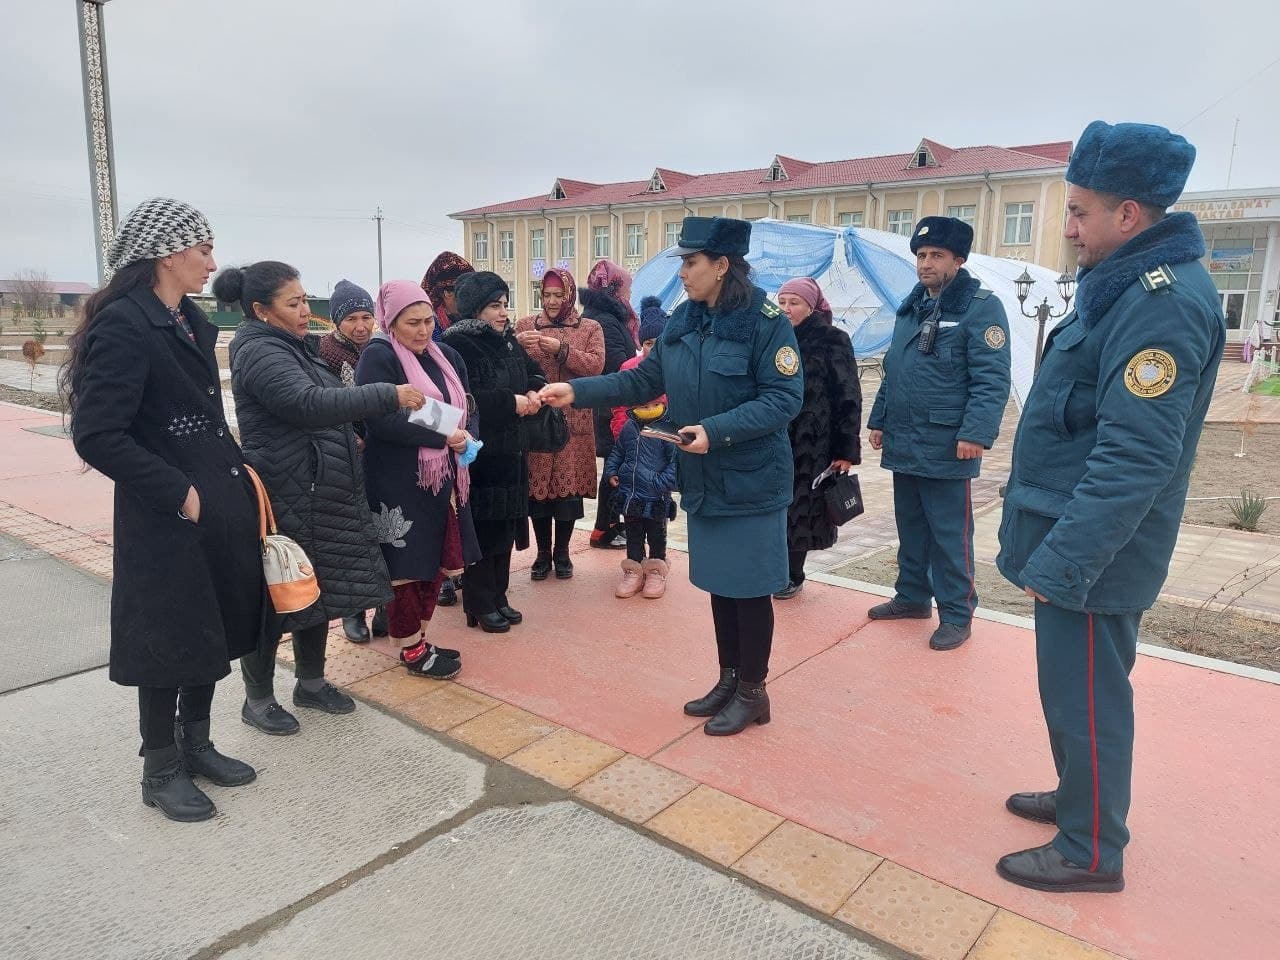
[867,216,1009,650]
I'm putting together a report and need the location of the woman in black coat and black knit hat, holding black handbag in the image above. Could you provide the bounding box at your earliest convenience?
[444,270,547,634]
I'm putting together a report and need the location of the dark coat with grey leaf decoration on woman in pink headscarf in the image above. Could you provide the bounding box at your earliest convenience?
[356,335,480,580]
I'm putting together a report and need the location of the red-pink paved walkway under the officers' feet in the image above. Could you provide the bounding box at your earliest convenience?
[0,404,1280,960]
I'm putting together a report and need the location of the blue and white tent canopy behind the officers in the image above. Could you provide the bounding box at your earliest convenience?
[631,220,1061,407]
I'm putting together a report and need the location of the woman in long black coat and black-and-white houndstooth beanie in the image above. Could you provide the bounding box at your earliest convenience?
[61,198,265,820]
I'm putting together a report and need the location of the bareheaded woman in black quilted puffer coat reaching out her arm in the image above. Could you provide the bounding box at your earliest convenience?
[222,260,424,735]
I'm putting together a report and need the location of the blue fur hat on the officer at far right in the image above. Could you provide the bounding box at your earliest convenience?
[1066,120,1196,209]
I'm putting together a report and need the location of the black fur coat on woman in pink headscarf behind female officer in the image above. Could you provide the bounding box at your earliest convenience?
[787,316,863,550]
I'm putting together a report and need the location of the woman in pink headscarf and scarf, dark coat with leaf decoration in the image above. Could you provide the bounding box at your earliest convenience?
[356,280,480,680]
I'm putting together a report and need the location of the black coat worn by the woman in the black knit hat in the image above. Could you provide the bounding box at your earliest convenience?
[444,320,547,557]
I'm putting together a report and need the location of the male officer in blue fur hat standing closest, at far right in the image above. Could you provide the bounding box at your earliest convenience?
[996,120,1225,892]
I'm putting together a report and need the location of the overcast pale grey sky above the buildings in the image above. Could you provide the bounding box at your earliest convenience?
[0,0,1280,294]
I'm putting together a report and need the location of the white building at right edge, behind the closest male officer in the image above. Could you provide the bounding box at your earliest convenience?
[1171,187,1280,342]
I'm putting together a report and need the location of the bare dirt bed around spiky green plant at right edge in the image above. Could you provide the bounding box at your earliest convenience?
[1183,424,1280,534]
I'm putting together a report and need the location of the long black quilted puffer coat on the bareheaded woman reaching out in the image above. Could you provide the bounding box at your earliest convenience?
[229,320,399,631]
